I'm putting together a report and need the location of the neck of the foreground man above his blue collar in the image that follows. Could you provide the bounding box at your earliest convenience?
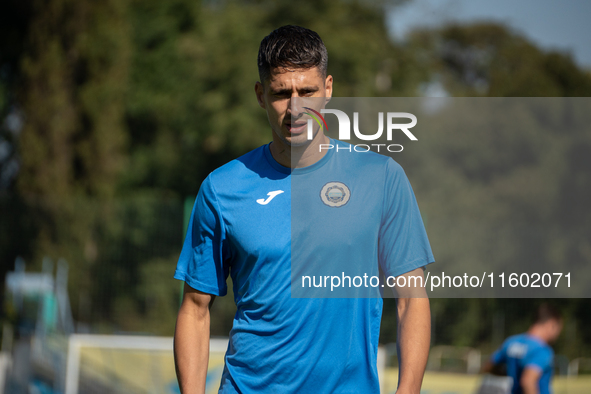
[269,133,330,168]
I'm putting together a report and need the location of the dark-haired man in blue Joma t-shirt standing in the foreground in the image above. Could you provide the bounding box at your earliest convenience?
[174,26,434,394]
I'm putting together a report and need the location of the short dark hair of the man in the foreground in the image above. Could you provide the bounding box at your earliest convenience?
[257,25,328,82]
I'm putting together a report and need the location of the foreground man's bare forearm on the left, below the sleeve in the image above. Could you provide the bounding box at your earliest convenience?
[174,283,215,394]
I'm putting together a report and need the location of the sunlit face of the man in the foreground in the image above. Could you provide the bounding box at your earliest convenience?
[255,67,332,149]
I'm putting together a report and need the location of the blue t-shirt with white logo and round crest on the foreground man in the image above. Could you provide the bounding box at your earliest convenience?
[174,140,434,393]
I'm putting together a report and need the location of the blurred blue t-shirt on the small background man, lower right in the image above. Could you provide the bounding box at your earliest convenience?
[492,334,554,394]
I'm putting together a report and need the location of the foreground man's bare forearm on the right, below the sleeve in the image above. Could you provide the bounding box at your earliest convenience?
[396,268,431,394]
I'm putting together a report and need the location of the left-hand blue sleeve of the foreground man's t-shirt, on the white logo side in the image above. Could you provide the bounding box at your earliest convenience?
[174,177,229,296]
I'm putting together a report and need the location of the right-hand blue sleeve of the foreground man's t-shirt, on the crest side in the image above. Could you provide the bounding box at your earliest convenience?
[379,159,435,276]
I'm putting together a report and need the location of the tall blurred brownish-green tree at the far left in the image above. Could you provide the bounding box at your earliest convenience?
[11,0,129,326]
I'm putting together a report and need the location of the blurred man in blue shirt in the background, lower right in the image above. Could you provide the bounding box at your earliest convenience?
[484,304,562,394]
